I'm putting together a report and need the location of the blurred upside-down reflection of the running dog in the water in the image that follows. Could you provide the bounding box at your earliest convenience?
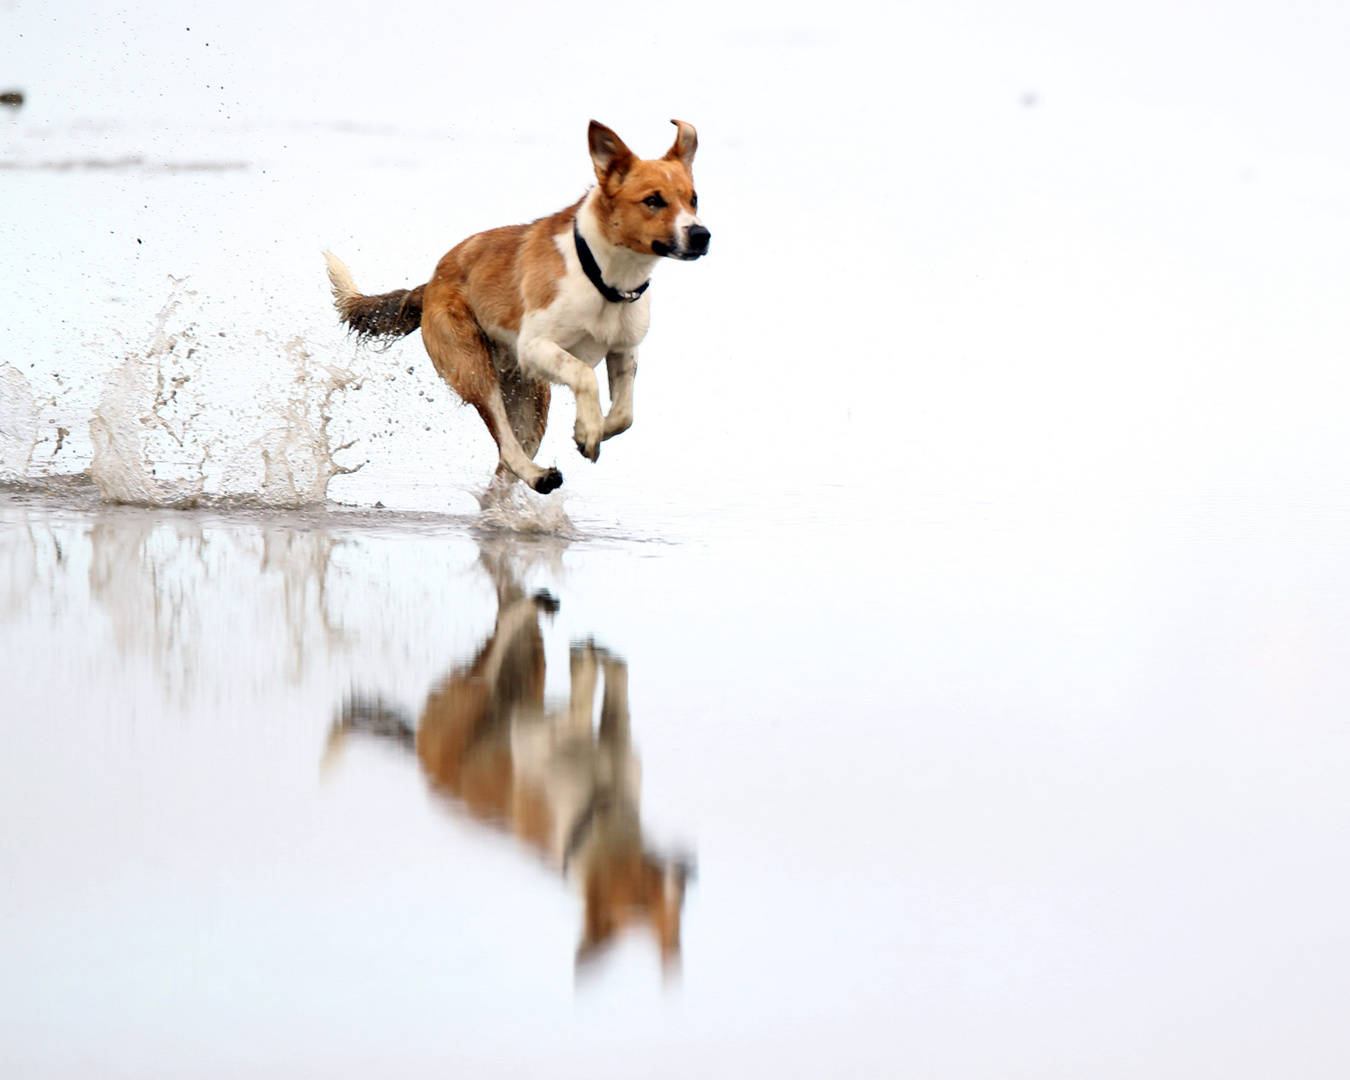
[322,545,690,973]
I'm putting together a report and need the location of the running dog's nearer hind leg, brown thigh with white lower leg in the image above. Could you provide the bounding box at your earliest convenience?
[423,282,563,494]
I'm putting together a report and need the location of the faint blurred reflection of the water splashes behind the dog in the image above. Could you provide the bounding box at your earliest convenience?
[0,499,351,706]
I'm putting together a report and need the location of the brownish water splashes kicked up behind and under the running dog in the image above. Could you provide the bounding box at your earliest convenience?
[0,275,576,518]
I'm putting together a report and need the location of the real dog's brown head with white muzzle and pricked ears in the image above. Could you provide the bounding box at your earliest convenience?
[590,120,711,259]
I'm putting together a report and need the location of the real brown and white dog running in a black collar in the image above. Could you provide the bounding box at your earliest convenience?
[324,120,710,493]
